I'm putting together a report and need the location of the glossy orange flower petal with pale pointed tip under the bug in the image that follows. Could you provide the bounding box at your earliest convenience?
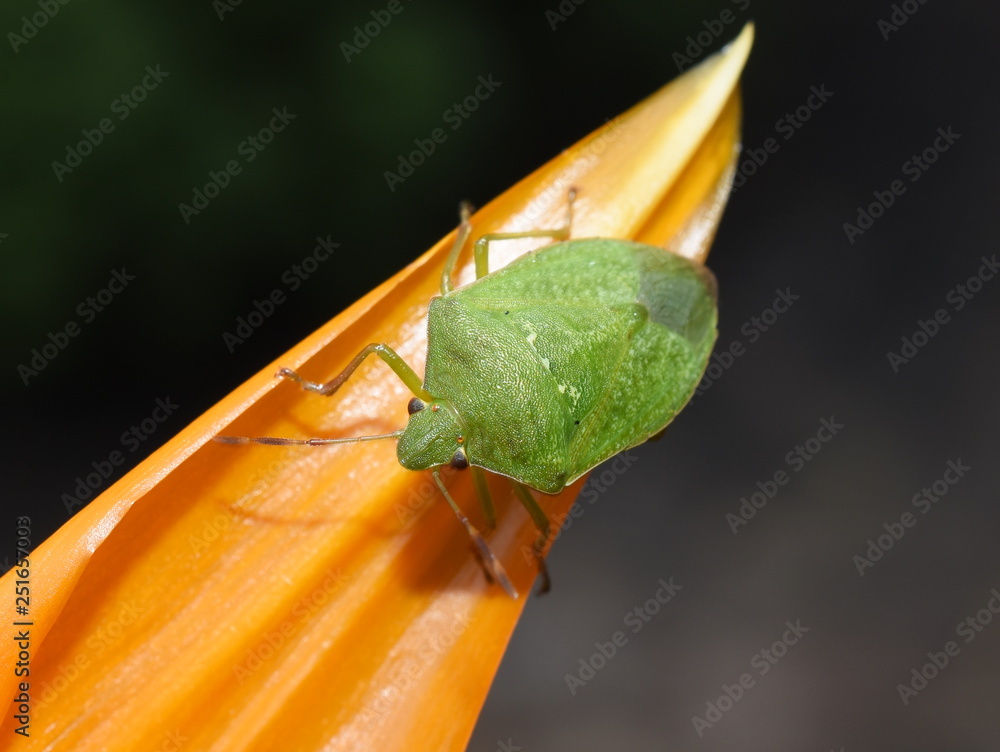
[0,27,752,752]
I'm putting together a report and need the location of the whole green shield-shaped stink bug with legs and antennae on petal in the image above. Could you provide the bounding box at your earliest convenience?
[216,190,717,598]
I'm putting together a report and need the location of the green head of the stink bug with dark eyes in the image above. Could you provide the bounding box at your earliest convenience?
[396,397,469,470]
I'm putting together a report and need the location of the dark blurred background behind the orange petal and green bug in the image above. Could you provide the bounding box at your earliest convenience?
[0,0,1000,752]
